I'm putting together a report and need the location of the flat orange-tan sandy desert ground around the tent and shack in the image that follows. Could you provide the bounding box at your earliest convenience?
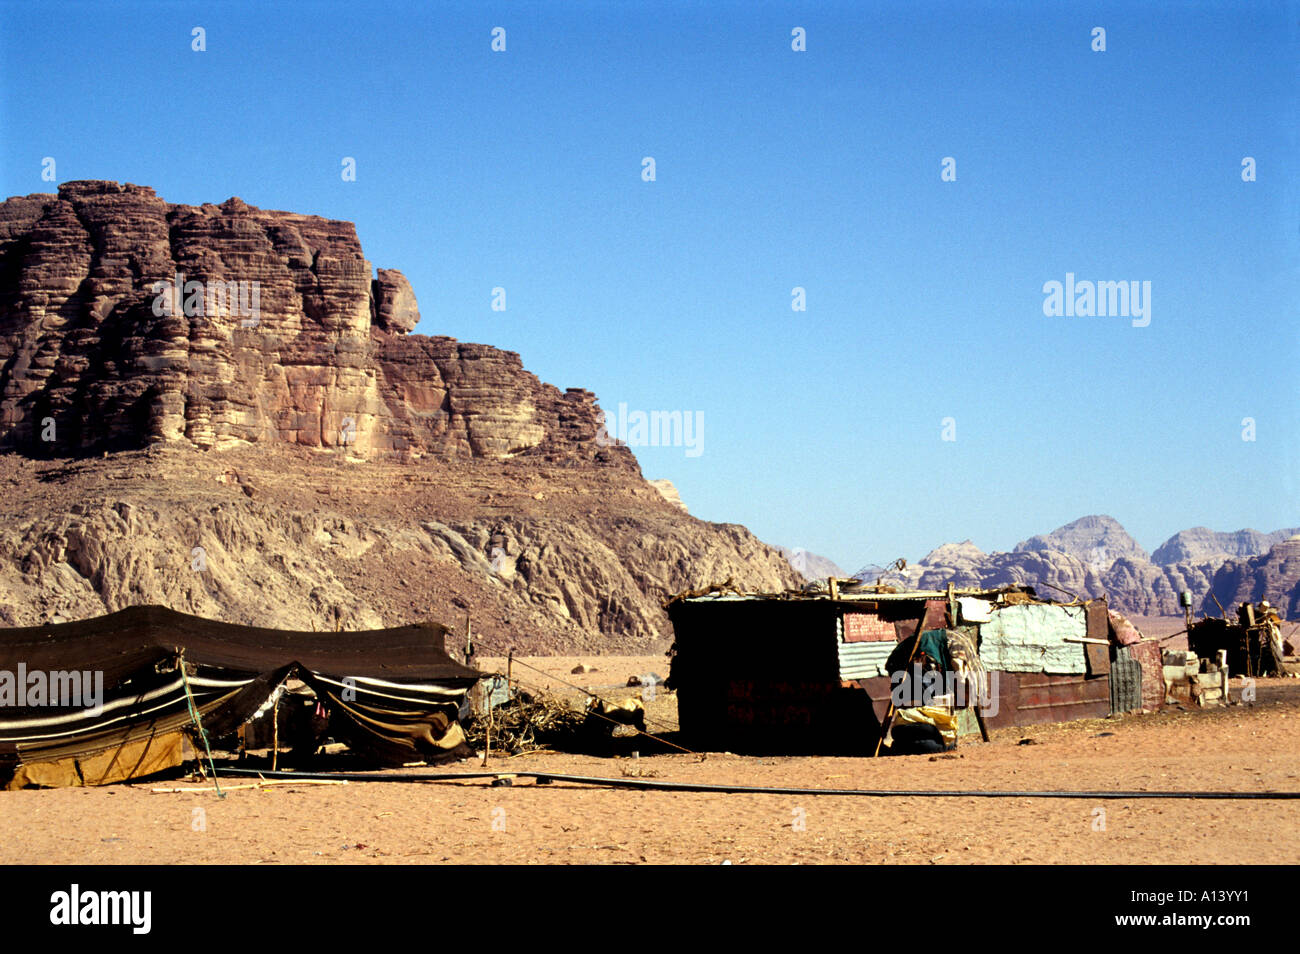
[0,656,1300,864]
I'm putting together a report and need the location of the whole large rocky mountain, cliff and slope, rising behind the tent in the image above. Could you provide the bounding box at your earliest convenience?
[0,182,797,652]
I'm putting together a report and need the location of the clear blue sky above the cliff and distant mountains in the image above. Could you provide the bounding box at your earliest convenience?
[0,3,1300,571]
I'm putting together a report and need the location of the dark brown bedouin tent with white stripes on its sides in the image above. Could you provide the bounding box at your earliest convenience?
[0,606,478,789]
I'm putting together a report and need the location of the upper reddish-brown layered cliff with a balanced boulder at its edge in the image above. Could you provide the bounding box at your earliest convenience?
[0,181,636,471]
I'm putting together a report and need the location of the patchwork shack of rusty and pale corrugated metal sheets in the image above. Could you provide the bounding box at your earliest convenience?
[668,581,1164,754]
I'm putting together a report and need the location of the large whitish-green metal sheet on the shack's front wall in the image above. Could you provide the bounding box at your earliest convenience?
[979,603,1088,676]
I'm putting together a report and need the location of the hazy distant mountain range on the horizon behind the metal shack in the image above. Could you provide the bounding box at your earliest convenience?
[796,515,1300,619]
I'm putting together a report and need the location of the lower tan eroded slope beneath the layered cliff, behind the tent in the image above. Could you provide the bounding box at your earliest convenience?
[0,443,797,655]
